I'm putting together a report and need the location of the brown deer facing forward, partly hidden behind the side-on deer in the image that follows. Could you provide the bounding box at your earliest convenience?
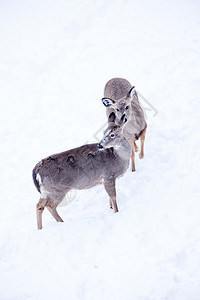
[102,78,147,172]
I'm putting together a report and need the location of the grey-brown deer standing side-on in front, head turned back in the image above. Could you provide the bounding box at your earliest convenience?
[32,114,131,229]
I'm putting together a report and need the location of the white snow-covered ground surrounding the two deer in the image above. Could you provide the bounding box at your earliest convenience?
[0,0,200,300]
